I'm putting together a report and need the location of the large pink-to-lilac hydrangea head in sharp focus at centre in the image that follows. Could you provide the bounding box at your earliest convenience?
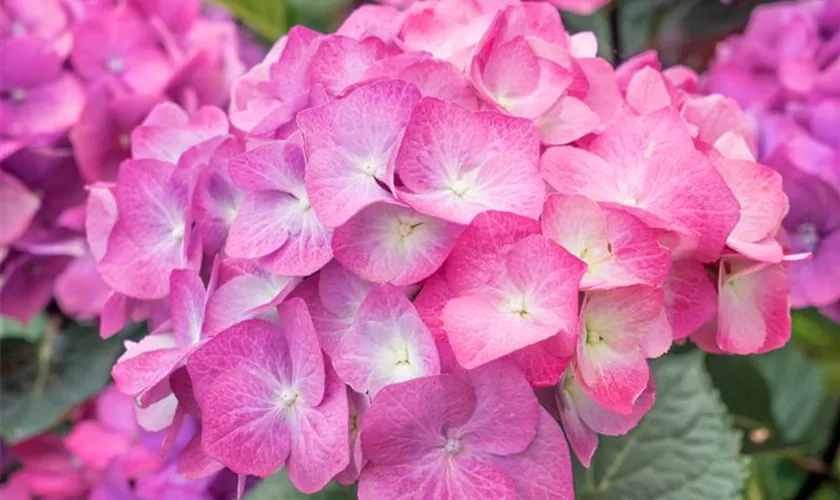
[87,0,790,499]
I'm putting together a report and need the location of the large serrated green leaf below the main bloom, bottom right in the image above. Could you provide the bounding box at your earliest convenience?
[576,352,747,500]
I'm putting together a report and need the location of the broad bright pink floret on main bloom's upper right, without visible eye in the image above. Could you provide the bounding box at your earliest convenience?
[542,110,740,261]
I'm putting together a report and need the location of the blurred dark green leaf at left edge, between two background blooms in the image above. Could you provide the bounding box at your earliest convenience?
[0,325,133,444]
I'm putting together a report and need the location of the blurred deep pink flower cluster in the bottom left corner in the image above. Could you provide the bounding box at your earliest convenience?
[0,386,243,500]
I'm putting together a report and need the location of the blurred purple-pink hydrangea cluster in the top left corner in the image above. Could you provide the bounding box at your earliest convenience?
[0,0,261,322]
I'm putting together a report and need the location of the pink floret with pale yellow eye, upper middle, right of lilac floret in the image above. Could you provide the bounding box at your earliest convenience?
[396,97,545,224]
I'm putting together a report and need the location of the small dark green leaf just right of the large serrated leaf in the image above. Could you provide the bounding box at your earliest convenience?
[706,356,776,433]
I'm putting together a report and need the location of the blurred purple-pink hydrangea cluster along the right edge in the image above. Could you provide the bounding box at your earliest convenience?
[702,0,840,322]
